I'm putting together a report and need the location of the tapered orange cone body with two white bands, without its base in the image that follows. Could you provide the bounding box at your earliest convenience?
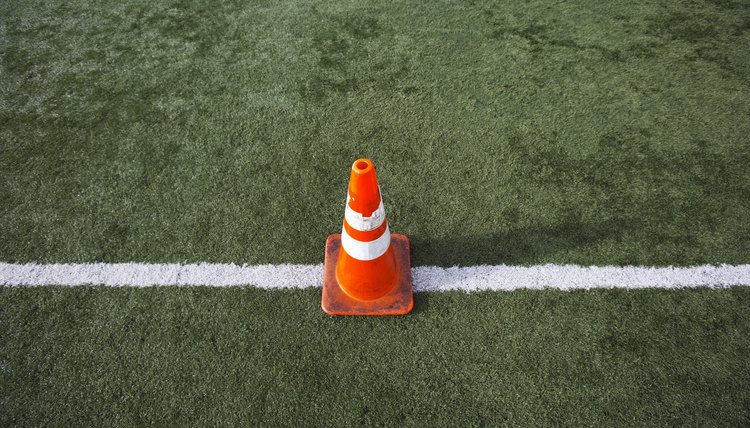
[336,159,398,300]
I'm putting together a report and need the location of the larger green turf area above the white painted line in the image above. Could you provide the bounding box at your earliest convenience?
[0,0,750,265]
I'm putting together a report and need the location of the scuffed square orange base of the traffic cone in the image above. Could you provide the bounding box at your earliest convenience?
[321,233,414,315]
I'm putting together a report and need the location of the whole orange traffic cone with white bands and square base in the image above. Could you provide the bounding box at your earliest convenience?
[322,159,414,315]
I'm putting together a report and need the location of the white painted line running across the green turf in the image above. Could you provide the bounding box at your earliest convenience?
[0,263,750,291]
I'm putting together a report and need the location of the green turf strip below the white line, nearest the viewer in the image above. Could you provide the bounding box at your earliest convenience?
[0,287,750,427]
